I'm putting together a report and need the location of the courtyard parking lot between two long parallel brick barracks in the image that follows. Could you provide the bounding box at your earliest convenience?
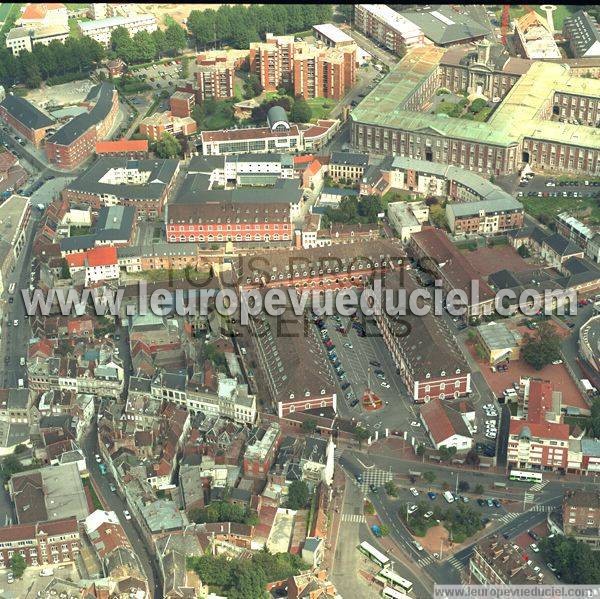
[310,316,428,443]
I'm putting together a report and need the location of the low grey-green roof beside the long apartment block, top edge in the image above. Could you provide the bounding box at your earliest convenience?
[400,4,490,46]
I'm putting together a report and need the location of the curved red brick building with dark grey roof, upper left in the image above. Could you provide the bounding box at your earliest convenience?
[46,82,119,170]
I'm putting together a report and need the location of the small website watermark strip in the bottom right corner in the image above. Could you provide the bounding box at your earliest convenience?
[433,584,600,599]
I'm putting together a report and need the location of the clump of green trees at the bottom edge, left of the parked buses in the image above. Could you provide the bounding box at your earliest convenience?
[188,549,308,599]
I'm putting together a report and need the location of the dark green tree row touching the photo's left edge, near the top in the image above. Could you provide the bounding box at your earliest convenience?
[0,37,106,88]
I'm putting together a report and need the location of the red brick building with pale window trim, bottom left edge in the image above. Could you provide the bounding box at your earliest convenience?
[0,518,79,568]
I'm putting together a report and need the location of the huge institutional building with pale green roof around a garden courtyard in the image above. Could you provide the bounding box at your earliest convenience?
[351,40,600,175]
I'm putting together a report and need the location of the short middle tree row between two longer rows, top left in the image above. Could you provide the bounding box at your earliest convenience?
[110,22,187,64]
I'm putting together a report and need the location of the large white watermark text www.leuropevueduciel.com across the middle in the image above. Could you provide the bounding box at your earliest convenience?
[21,279,577,325]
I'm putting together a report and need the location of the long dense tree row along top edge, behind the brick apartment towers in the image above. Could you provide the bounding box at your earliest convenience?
[187,4,333,48]
